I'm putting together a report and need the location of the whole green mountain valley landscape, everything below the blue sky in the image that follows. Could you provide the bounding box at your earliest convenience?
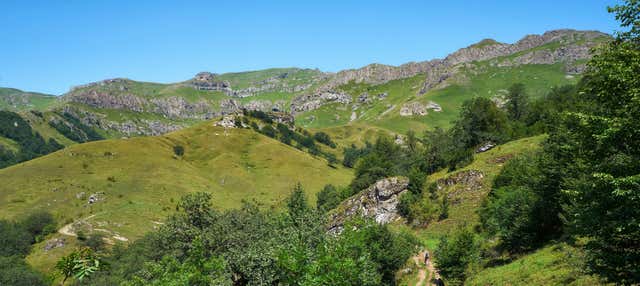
[0,7,640,285]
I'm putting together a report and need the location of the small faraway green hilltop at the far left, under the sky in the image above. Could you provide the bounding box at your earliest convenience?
[0,87,57,111]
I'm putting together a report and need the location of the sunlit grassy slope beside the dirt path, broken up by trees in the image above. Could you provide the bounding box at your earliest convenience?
[393,136,601,285]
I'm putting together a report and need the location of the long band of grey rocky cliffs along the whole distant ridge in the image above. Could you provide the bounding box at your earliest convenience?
[48,30,608,135]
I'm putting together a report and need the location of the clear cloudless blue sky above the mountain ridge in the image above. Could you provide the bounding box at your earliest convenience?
[0,0,619,94]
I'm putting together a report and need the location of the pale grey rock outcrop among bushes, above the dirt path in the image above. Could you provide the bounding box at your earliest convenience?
[329,177,409,233]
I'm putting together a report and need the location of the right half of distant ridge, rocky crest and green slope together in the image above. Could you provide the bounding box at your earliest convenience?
[292,30,610,132]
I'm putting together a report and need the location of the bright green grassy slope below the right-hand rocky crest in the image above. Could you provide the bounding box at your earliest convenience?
[297,62,578,133]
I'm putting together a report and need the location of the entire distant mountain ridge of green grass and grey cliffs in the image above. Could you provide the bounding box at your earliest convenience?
[0,30,610,138]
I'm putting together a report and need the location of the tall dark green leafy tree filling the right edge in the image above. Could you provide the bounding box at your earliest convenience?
[552,0,640,284]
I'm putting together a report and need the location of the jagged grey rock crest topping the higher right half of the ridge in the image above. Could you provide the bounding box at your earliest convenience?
[292,30,609,113]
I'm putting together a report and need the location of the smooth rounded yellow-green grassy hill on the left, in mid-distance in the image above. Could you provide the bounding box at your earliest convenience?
[0,122,351,239]
